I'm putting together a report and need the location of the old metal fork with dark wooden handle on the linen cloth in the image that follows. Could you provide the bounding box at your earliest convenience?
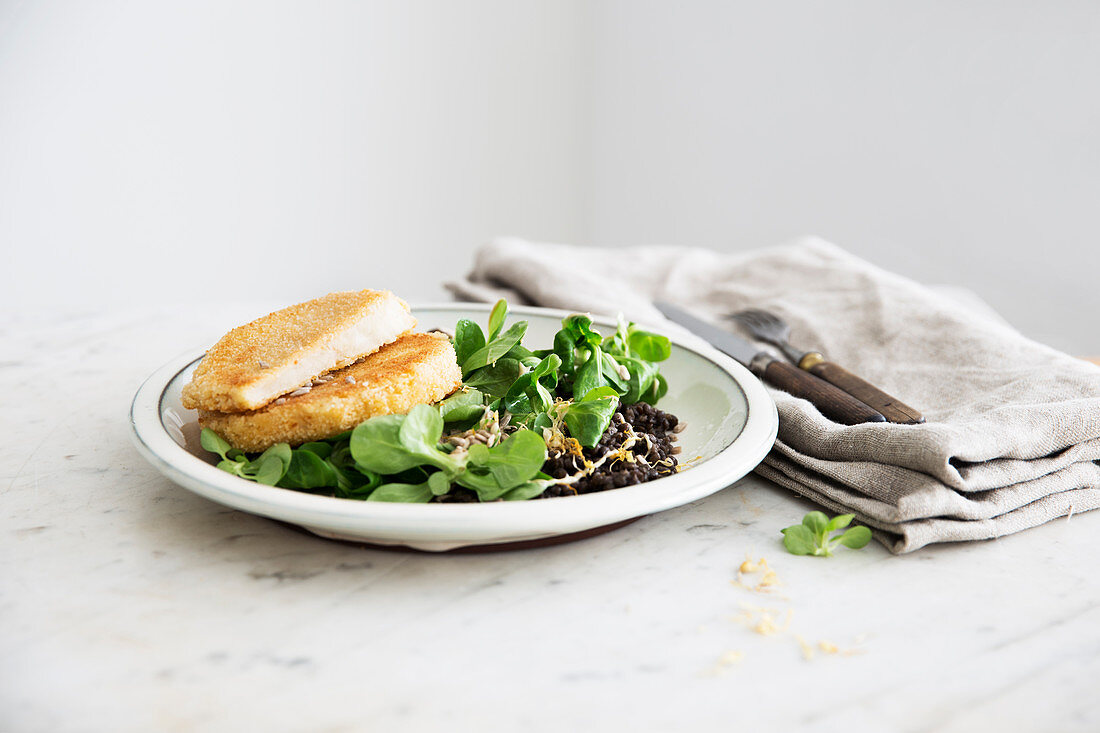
[729,308,924,425]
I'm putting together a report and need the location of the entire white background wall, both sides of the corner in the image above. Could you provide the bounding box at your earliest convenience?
[0,0,1100,352]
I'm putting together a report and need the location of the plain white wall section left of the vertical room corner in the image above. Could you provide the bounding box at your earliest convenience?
[0,0,585,307]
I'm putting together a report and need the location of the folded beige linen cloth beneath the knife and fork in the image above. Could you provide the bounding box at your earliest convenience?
[449,238,1100,553]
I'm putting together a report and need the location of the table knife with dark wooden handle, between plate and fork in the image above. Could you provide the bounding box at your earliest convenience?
[653,302,887,425]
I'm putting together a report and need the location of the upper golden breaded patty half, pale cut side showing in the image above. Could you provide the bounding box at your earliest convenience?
[180,291,416,412]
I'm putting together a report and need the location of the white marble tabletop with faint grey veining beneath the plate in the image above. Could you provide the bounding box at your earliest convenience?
[0,304,1100,733]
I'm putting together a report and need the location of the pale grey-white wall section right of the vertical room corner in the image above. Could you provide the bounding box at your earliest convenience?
[585,0,1100,353]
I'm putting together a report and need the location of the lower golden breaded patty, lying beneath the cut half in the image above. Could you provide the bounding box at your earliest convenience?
[199,333,462,452]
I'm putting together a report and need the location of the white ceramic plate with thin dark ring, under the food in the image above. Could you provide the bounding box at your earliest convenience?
[130,304,779,551]
